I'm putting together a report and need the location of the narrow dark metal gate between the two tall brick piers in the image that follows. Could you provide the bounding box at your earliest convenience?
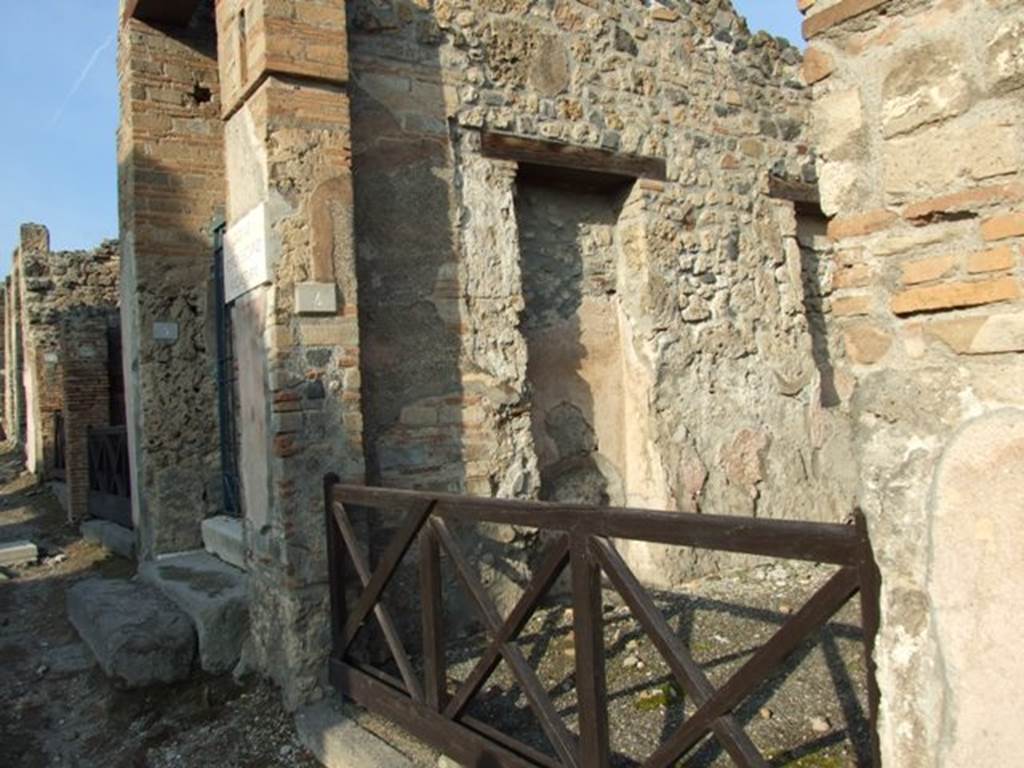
[213,224,242,517]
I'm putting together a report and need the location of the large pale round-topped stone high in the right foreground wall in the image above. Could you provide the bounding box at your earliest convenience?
[882,40,972,136]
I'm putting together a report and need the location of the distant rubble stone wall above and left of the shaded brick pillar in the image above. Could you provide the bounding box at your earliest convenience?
[12,224,120,478]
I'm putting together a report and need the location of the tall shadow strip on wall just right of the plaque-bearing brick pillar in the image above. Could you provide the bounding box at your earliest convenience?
[348,18,472,663]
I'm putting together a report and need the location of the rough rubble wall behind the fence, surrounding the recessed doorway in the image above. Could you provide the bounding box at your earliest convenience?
[349,0,854,583]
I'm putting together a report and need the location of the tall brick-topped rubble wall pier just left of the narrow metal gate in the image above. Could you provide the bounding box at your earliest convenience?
[118,0,224,558]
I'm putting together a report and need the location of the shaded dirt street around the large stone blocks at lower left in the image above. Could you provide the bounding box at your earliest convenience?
[0,449,319,768]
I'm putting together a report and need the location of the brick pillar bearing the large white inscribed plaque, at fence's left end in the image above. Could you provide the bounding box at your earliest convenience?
[217,0,364,706]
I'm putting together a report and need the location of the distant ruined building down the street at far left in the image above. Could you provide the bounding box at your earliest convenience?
[3,224,120,519]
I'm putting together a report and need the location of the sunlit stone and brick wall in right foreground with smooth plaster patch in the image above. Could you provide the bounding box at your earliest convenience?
[802,0,1024,768]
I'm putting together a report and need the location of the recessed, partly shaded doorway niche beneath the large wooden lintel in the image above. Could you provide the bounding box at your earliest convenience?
[516,176,629,506]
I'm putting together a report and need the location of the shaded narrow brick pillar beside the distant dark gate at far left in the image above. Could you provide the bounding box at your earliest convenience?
[60,314,110,522]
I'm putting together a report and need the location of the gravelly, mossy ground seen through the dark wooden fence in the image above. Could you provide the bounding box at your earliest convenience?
[450,564,870,768]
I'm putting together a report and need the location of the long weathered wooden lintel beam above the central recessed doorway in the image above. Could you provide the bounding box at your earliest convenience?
[481,132,666,181]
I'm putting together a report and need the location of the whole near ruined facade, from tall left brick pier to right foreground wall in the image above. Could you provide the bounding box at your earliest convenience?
[101,0,1024,765]
